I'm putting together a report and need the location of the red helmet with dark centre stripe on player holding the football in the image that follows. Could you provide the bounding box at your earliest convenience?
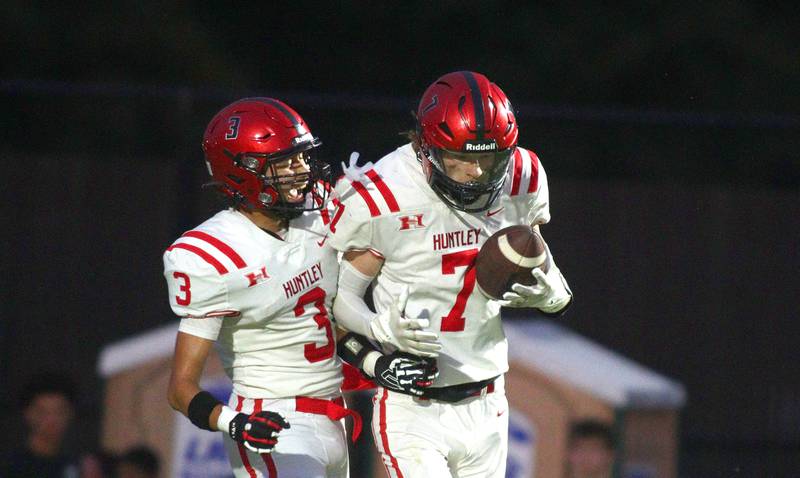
[417,71,519,212]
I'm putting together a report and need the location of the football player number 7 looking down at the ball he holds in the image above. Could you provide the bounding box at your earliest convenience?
[329,71,572,478]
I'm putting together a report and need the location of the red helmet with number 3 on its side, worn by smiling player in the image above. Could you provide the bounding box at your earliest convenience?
[203,98,330,218]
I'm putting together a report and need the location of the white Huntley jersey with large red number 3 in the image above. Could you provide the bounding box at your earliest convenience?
[164,209,342,398]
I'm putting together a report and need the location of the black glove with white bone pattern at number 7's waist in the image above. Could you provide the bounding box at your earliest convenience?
[374,352,439,397]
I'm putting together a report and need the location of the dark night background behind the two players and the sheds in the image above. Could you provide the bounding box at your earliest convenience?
[0,0,800,478]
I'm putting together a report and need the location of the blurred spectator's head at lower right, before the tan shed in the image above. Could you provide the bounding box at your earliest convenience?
[567,419,616,478]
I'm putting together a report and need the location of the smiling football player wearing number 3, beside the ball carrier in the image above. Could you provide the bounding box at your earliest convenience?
[164,98,360,478]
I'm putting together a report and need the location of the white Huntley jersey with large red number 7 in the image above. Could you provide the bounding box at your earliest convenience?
[329,144,550,387]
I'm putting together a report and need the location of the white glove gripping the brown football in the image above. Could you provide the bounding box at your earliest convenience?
[498,263,572,314]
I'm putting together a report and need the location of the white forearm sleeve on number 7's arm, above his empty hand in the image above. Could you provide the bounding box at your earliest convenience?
[333,260,376,339]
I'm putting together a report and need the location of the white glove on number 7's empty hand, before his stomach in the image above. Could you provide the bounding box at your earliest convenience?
[369,287,442,357]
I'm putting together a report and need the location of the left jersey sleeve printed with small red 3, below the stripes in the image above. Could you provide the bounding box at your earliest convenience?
[164,249,233,340]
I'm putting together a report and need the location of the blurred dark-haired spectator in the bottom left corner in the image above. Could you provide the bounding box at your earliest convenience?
[0,373,78,478]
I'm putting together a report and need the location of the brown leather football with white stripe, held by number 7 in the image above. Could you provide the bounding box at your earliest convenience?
[475,226,550,299]
